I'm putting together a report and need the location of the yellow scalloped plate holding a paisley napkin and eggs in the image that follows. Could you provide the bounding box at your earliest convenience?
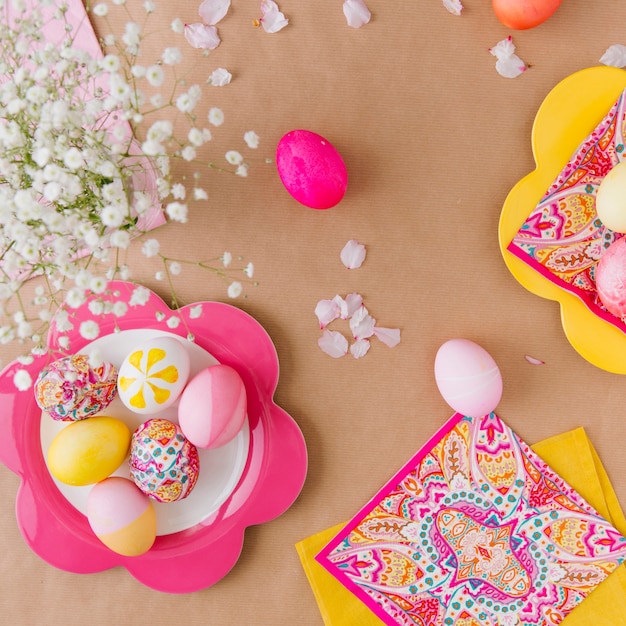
[498,66,626,374]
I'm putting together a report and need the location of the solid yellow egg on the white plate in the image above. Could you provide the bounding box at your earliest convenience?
[47,415,130,486]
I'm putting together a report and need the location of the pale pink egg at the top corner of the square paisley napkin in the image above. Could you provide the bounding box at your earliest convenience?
[435,339,502,417]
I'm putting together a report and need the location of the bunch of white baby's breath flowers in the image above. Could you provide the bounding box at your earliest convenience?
[0,0,258,364]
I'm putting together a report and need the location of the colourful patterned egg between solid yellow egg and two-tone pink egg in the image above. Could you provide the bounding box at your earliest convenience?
[129,418,200,502]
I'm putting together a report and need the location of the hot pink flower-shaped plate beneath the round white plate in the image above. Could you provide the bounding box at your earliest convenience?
[0,281,307,593]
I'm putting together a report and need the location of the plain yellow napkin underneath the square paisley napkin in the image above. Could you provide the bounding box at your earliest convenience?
[296,428,626,626]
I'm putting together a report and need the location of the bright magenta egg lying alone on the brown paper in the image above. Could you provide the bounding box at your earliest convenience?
[276,130,348,209]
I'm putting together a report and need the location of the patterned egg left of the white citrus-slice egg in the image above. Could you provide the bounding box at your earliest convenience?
[35,354,117,422]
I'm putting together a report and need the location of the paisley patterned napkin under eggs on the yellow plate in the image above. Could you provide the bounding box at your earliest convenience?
[507,92,626,331]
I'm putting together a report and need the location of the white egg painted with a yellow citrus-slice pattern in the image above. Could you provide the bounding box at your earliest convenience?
[117,337,189,414]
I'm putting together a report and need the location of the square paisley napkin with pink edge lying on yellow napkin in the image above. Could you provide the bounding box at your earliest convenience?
[316,413,626,626]
